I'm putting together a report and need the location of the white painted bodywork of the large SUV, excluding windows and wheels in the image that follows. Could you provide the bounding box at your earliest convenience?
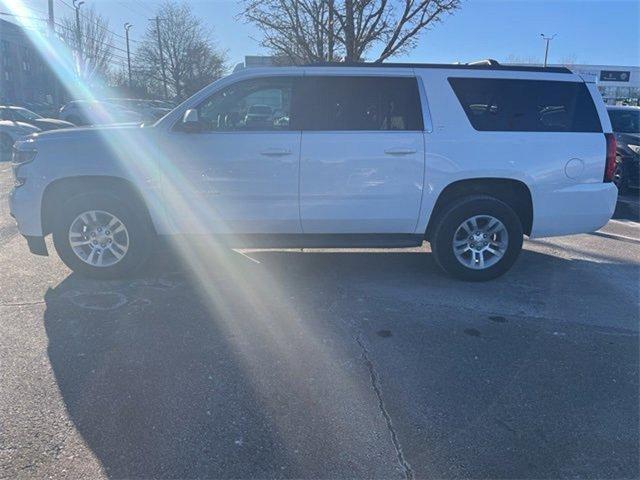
[10,67,617,242]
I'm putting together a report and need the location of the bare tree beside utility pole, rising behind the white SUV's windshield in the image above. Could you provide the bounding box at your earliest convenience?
[135,1,225,99]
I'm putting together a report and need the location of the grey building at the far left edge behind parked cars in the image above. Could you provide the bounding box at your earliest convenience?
[0,19,57,105]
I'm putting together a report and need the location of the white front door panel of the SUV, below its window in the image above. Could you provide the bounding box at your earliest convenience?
[162,132,302,234]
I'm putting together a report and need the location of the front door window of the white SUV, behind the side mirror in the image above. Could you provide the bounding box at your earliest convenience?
[198,77,293,131]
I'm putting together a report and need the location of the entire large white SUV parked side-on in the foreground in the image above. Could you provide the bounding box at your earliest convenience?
[10,61,617,281]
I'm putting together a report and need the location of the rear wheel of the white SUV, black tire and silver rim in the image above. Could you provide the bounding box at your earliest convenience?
[431,196,523,281]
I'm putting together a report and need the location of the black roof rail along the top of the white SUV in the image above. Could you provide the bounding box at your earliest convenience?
[301,59,572,73]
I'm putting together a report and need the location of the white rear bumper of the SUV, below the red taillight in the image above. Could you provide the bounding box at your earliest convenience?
[530,183,618,238]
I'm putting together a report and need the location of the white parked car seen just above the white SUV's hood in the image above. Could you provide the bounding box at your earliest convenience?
[58,100,142,126]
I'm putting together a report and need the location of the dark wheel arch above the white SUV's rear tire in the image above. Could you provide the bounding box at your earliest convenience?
[425,177,534,240]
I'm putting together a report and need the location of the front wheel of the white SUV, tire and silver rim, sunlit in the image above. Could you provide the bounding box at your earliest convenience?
[53,192,153,278]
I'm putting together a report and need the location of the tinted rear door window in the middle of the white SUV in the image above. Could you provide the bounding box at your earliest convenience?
[298,76,423,131]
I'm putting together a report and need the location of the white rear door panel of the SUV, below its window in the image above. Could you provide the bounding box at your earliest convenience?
[300,132,424,233]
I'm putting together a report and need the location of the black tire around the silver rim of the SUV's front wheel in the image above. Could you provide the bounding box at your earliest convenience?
[52,191,155,279]
